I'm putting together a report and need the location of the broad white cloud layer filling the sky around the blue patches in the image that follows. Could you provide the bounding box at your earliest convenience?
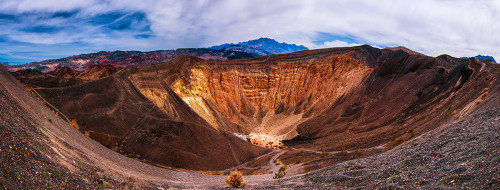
[0,0,500,62]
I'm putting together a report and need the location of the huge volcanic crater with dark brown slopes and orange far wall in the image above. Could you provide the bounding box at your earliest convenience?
[9,45,500,184]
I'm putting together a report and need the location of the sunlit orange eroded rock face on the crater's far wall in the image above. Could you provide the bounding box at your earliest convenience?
[172,52,372,144]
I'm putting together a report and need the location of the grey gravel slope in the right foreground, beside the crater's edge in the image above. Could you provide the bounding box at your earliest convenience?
[252,108,500,189]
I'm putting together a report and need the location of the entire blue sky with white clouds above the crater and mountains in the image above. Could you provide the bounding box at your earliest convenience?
[0,0,500,64]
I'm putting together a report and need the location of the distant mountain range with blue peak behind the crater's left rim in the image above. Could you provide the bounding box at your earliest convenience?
[8,38,308,72]
